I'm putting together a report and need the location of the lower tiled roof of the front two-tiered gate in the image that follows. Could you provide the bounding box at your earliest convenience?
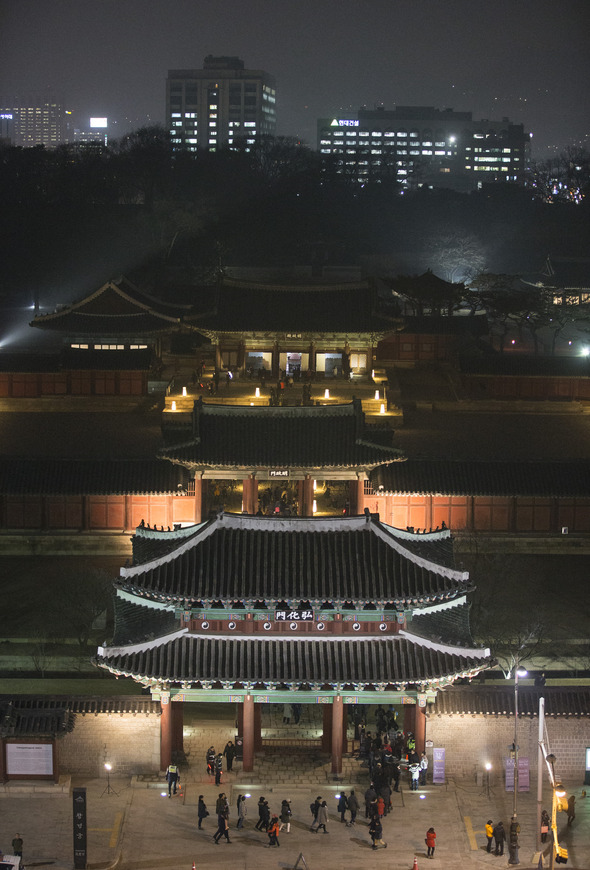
[97,635,482,684]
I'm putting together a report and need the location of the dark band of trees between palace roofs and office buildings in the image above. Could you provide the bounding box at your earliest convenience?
[0,127,590,303]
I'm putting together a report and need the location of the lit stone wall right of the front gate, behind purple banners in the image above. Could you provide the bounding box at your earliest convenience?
[426,714,590,787]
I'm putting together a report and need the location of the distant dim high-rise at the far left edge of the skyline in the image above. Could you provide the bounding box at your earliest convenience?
[0,94,68,148]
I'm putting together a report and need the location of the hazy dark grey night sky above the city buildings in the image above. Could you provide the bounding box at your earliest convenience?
[0,0,590,157]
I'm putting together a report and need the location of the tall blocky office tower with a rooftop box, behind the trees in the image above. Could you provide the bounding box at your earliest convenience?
[166,55,276,151]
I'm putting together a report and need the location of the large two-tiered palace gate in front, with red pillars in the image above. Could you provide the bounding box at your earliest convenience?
[96,510,491,774]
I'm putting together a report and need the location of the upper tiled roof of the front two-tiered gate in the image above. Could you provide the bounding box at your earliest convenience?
[118,515,467,603]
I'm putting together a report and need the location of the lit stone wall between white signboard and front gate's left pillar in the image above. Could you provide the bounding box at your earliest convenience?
[57,713,160,777]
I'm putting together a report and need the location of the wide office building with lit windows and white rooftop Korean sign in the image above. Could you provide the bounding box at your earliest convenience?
[318,106,528,190]
